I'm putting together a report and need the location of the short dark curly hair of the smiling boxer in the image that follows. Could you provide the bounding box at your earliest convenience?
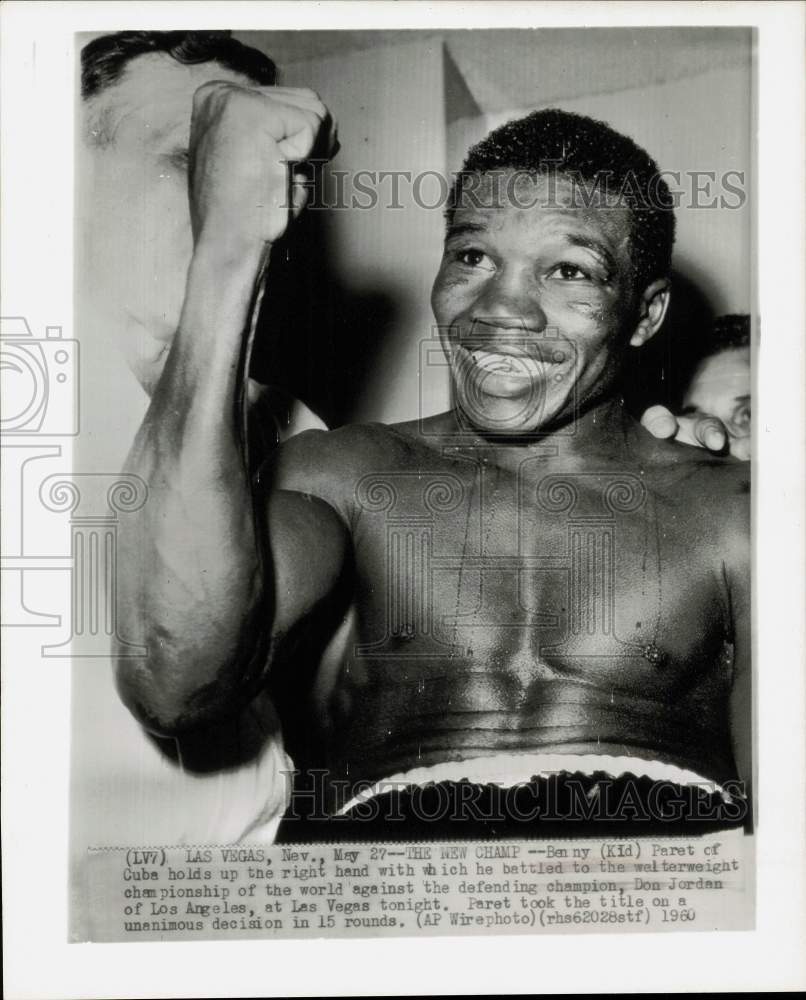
[447,108,675,287]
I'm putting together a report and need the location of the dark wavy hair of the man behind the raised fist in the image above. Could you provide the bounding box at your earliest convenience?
[81,31,277,98]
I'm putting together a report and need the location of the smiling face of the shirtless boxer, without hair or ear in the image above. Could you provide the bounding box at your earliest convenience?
[431,175,635,434]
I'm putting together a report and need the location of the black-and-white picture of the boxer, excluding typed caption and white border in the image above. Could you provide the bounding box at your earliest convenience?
[74,23,754,843]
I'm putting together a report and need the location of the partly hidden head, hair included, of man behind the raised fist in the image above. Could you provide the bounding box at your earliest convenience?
[79,31,276,389]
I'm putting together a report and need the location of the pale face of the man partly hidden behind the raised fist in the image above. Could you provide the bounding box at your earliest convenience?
[79,53,258,391]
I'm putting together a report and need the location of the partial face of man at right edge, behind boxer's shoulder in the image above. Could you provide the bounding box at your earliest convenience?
[683,347,751,459]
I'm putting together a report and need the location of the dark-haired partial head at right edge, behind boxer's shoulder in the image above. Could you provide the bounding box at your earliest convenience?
[682,314,751,461]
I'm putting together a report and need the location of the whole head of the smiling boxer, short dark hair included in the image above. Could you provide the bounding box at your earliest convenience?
[432,109,675,436]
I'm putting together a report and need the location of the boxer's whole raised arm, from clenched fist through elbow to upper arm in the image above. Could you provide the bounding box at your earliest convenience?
[117,82,346,735]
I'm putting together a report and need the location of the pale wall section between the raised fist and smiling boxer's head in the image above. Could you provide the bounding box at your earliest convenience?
[282,38,449,421]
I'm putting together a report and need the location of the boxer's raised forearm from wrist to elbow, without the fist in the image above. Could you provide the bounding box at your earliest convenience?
[118,240,270,733]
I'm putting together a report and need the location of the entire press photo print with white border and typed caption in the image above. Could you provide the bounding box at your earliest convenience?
[1,3,803,996]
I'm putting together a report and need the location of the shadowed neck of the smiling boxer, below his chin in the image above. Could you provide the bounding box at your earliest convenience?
[452,396,636,466]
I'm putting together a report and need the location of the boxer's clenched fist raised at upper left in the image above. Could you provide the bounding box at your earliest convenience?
[188,80,337,255]
